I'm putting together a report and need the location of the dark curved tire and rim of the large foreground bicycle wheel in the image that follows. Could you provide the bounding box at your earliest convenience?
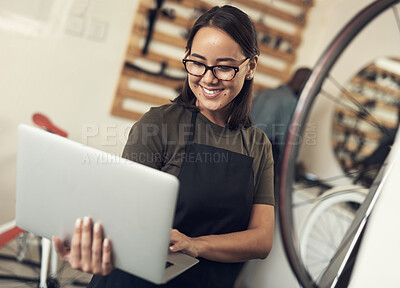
[279,0,400,288]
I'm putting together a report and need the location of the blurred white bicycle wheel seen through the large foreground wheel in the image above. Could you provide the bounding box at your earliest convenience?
[300,185,368,281]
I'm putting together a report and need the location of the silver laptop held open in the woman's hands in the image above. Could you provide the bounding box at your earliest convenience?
[16,124,198,284]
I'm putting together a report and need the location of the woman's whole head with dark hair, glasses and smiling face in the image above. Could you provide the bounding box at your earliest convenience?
[175,6,260,129]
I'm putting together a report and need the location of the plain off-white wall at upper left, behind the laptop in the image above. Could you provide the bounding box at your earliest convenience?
[0,0,138,224]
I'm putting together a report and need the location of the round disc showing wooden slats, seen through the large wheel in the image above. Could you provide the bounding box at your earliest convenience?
[332,57,400,187]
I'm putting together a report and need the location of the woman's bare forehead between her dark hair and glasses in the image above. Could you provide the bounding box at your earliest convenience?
[191,27,244,60]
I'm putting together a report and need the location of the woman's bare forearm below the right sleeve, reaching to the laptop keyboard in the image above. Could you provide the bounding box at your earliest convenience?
[193,229,273,262]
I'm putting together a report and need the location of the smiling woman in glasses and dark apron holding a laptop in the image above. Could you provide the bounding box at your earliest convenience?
[55,5,274,288]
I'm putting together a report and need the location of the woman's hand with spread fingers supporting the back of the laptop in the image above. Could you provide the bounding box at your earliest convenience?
[53,217,113,275]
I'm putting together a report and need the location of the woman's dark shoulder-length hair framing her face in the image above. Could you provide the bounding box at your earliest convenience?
[174,5,260,129]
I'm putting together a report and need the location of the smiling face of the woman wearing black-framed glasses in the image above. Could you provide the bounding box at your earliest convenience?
[188,27,257,126]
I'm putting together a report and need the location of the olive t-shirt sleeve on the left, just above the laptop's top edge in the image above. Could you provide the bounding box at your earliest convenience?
[122,108,164,170]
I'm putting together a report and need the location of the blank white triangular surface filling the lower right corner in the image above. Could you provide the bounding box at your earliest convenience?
[349,129,400,288]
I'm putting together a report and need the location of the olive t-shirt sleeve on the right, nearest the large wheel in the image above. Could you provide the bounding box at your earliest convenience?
[253,133,275,205]
